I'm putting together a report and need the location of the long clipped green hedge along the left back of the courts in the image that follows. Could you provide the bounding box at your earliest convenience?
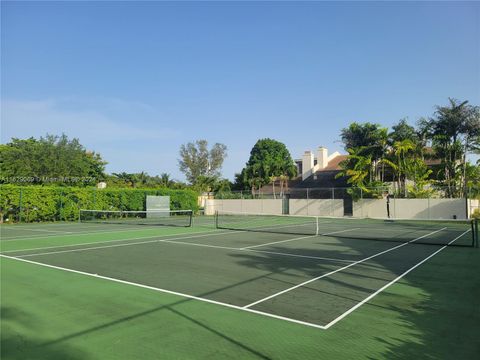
[0,185,198,222]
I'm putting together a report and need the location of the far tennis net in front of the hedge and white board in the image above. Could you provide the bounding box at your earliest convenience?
[79,210,193,227]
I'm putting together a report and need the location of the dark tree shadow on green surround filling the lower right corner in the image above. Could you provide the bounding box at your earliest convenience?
[372,248,480,360]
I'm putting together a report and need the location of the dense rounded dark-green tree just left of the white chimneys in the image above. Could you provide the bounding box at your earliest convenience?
[240,138,297,193]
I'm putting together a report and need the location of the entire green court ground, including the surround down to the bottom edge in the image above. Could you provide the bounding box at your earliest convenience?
[0,217,480,359]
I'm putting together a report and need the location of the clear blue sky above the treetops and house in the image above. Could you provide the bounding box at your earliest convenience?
[1,2,480,180]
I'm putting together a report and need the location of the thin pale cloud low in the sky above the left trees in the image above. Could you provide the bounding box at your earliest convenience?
[1,99,179,146]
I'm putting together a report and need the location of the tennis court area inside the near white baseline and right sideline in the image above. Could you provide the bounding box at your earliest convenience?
[1,213,476,330]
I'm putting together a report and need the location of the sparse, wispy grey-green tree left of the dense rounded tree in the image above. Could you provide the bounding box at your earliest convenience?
[178,140,227,184]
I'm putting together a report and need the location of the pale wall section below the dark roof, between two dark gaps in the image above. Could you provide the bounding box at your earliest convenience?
[289,199,343,216]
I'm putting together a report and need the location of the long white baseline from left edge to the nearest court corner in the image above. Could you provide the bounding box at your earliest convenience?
[0,254,325,329]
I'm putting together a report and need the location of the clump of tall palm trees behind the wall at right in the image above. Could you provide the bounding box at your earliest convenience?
[339,99,480,197]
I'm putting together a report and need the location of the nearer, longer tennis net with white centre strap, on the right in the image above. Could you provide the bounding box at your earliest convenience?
[215,211,478,246]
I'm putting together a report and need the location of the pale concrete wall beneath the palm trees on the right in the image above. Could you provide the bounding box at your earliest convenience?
[353,199,467,219]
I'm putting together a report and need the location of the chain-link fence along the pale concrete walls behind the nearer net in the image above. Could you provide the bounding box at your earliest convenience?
[211,186,480,219]
